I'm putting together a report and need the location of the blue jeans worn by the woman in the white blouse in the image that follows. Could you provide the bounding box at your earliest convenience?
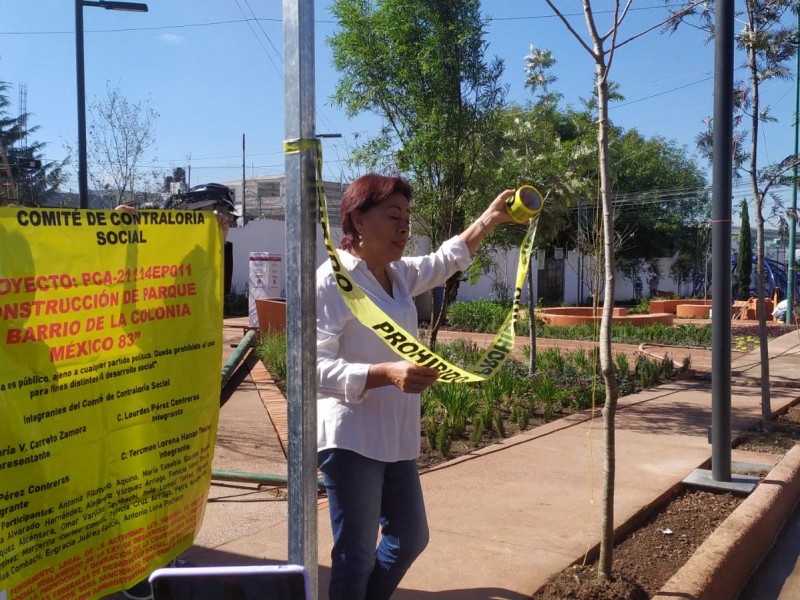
[319,448,429,600]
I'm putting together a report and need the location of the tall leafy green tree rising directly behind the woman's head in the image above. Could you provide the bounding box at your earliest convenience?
[329,0,505,343]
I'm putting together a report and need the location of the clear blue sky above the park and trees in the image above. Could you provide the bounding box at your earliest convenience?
[0,0,795,211]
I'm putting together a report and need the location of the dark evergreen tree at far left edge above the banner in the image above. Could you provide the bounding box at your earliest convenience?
[0,81,67,206]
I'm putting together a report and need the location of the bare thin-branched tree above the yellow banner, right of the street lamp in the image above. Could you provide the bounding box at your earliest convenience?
[87,84,158,208]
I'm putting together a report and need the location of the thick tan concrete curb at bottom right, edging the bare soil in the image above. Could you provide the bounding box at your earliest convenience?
[653,445,800,600]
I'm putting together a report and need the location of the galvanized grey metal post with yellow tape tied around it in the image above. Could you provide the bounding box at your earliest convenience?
[283,0,318,598]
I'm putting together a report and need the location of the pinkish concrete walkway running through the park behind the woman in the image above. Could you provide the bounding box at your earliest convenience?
[108,322,800,600]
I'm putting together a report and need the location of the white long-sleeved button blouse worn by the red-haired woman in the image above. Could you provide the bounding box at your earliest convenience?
[317,236,470,462]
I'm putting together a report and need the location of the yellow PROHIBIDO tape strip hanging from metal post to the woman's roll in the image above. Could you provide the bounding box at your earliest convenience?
[284,139,541,382]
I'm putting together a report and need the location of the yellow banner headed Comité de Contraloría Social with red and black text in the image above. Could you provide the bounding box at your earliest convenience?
[0,207,222,600]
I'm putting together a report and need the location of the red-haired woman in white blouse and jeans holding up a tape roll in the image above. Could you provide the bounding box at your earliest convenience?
[317,174,514,600]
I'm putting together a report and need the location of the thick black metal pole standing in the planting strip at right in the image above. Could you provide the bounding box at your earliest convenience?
[711,0,734,481]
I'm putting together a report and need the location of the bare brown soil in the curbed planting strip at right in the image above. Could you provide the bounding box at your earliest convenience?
[532,406,800,600]
